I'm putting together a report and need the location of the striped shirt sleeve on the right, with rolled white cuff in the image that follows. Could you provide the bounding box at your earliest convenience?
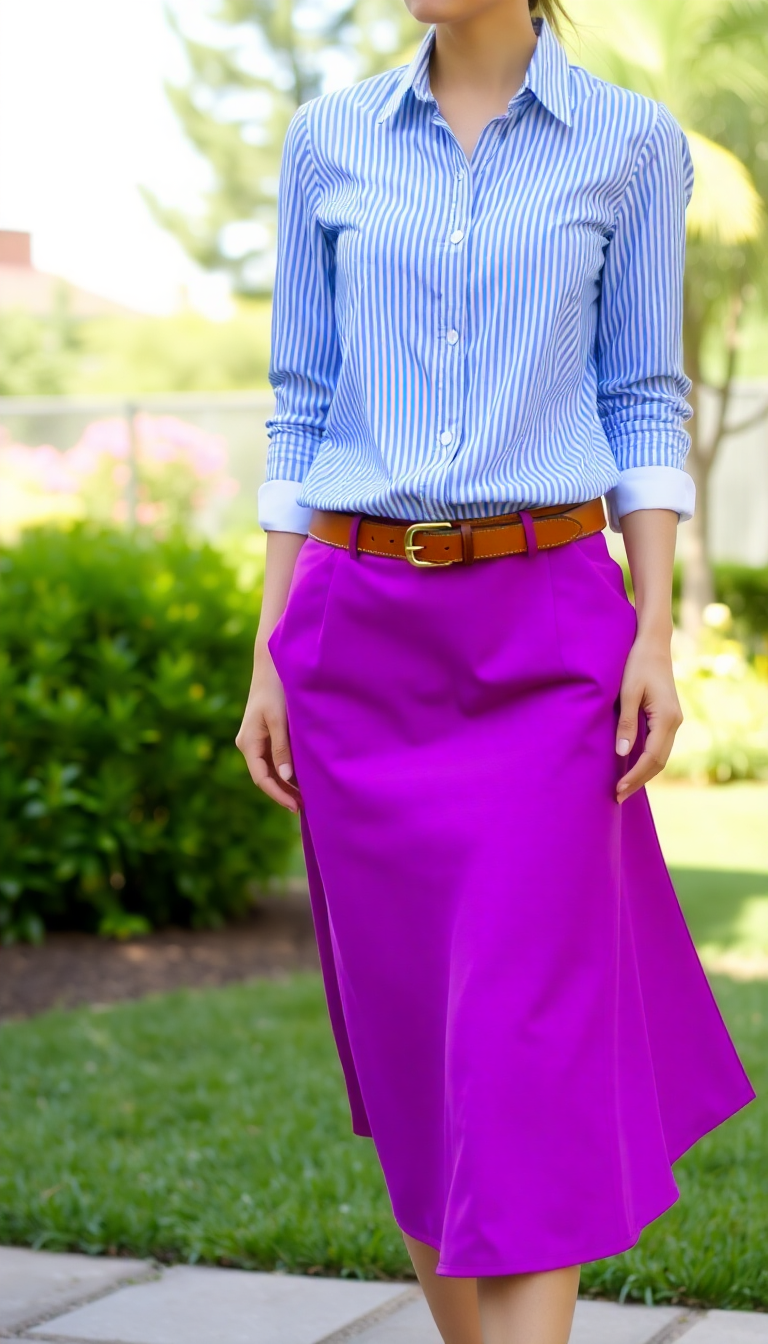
[597,102,695,531]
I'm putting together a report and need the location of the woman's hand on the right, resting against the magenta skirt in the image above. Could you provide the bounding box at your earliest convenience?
[616,632,683,802]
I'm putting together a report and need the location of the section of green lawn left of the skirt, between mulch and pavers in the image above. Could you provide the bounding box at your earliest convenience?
[0,973,405,1275]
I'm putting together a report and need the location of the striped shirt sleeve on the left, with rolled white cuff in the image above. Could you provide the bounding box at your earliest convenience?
[258,103,339,534]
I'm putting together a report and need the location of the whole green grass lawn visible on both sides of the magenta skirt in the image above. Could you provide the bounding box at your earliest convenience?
[0,786,768,1309]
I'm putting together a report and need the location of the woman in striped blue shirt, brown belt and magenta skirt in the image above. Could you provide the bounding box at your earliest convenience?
[237,0,755,1344]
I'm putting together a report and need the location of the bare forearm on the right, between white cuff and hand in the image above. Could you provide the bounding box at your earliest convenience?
[621,508,678,645]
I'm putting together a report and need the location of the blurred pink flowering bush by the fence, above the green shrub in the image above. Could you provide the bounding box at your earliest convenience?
[0,411,238,531]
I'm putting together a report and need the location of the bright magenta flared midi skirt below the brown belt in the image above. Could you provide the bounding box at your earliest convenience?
[269,534,755,1277]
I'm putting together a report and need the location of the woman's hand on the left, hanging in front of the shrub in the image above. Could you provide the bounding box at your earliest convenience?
[234,645,301,812]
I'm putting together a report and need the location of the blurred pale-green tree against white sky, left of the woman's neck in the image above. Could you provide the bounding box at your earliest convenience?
[144,0,422,294]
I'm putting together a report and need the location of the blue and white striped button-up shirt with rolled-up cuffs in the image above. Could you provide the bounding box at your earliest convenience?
[260,19,694,532]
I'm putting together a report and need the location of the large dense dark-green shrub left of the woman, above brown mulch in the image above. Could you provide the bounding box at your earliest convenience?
[0,524,296,941]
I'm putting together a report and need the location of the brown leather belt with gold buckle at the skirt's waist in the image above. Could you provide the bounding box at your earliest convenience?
[309,496,605,569]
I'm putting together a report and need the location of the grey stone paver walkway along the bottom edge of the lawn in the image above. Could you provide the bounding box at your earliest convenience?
[0,1247,768,1344]
